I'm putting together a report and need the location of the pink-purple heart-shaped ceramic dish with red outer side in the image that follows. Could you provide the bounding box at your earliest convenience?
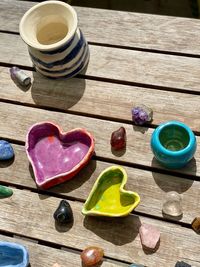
[26,122,94,189]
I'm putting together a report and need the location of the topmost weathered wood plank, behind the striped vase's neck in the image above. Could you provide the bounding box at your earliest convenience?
[0,0,200,55]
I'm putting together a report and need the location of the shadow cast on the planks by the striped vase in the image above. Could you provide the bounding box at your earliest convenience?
[31,71,86,110]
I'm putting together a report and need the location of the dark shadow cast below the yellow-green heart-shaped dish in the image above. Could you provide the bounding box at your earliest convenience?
[83,215,141,246]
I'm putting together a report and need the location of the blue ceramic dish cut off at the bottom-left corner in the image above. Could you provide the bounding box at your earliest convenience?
[0,242,29,267]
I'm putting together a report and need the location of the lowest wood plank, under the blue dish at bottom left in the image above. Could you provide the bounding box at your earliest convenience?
[0,235,120,267]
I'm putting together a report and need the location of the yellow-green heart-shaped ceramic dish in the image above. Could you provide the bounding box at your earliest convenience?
[82,166,140,217]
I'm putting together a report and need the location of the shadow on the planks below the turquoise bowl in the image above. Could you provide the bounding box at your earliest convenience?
[151,157,196,194]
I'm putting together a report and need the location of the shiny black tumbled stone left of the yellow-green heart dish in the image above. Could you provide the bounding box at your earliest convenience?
[53,200,73,224]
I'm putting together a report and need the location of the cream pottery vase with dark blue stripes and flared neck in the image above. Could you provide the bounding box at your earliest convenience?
[19,1,89,78]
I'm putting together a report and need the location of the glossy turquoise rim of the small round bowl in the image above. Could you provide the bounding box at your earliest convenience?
[152,121,196,157]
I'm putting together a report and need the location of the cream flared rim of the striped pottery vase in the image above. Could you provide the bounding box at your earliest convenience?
[19,1,78,51]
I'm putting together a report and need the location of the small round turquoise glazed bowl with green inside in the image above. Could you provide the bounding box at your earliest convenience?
[151,121,197,169]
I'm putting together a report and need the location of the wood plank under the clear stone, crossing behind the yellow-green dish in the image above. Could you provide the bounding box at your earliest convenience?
[0,142,200,224]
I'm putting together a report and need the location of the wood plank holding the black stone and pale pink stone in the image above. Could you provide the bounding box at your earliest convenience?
[0,189,200,267]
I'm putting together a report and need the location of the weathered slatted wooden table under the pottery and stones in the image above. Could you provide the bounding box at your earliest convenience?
[0,0,200,267]
